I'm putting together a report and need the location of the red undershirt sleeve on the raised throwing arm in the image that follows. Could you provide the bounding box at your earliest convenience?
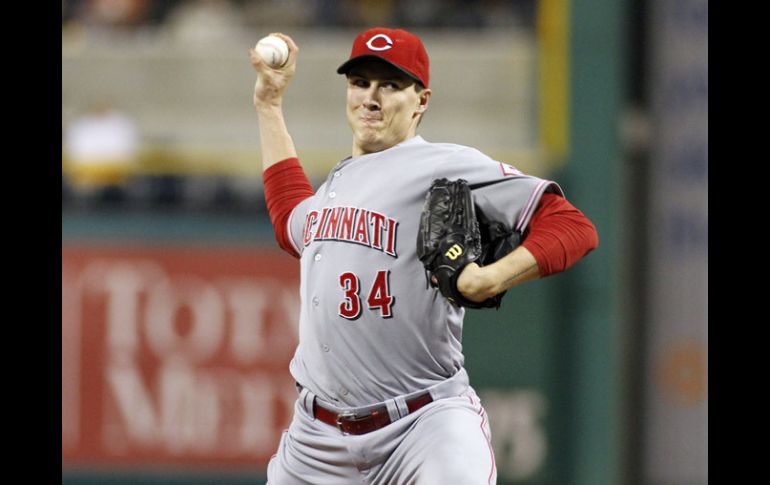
[263,157,314,258]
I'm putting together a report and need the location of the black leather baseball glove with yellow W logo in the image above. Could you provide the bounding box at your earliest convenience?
[417,178,516,308]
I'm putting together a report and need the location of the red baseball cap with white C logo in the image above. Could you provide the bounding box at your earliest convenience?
[337,27,430,88]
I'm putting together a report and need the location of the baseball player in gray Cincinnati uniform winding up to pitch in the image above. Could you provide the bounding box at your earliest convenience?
[250,28,598,485]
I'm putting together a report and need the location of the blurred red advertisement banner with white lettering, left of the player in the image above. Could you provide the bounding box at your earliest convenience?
[62,245,299,469]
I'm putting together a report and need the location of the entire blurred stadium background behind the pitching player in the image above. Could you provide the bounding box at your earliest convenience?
[62,0,708,485]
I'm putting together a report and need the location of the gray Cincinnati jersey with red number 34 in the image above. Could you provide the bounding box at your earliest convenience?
[288,136,561,407]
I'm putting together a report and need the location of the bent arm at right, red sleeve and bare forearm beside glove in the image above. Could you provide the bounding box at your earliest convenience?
[457,194,599,301]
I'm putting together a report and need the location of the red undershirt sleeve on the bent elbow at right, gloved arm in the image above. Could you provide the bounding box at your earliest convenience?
[522,193,599,277]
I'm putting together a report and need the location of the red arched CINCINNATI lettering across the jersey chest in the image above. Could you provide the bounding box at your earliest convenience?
[302,207,398,258]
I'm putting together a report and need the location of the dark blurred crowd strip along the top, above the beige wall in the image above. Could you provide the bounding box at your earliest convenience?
[62,0,535,31]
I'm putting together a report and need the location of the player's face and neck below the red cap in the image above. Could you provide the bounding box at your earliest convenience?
[347,61,431,156]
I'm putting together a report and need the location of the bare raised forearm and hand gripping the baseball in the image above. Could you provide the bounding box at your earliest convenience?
[249,33,299,170]
